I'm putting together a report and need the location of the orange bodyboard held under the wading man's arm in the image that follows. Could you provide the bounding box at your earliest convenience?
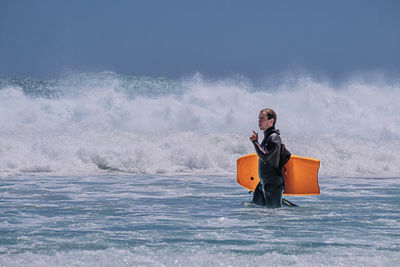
[237,153,320,195]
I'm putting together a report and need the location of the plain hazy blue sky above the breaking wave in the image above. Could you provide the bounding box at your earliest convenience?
[0,0,400,80]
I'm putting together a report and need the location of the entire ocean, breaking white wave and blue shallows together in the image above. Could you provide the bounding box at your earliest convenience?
[0,72,400,266]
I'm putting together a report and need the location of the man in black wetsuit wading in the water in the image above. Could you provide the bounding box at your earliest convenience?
[250,109,285,208]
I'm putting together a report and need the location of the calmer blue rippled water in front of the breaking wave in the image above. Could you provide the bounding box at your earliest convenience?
[0,173,400,266]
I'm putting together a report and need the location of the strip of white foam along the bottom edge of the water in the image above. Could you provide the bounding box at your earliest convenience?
[0,245,400,267]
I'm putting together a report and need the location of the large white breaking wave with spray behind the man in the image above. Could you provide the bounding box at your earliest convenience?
[0,72,400,177]
